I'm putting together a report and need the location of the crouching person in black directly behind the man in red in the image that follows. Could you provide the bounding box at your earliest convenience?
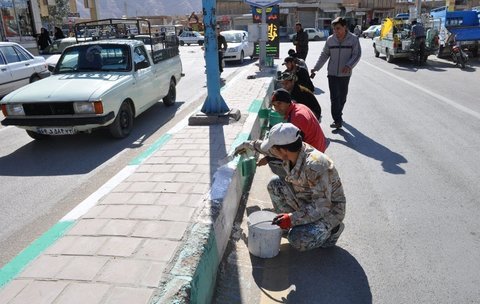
[277,72,322,120]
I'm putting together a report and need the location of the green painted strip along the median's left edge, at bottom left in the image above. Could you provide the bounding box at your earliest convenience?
[0,221,75,287]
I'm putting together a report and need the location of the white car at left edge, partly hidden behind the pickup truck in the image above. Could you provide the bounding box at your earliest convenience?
[0,42,50,97]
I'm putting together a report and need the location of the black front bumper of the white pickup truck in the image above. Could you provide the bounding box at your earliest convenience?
[2,112,115,127]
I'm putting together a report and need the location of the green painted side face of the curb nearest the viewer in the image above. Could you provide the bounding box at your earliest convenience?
[190,229,220,304]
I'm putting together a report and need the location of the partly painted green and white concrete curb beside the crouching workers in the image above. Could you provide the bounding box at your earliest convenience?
[151,68,276,304]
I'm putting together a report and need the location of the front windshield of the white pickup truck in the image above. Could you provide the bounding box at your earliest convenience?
[55,44,131,74]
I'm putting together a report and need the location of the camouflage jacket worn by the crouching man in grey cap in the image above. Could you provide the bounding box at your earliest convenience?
[283,143,346,226]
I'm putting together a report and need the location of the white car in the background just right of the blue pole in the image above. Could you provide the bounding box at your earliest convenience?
[220,30,254,63]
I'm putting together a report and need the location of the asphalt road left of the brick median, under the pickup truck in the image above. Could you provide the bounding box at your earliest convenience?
[0,45,248,267]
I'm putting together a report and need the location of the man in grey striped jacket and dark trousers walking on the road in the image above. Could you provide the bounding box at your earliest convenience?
[310,17,362,129]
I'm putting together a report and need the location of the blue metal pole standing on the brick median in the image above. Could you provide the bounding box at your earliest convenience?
[201,0,230,114]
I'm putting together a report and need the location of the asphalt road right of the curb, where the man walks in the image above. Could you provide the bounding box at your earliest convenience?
[215,39,480,304]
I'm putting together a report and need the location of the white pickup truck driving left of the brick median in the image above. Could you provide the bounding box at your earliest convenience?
[1,19,182,139]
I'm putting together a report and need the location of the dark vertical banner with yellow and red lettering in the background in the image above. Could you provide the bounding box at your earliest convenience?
[252,5,280,59]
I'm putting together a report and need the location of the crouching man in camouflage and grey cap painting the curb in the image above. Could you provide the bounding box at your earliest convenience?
[235,123,346,251]
